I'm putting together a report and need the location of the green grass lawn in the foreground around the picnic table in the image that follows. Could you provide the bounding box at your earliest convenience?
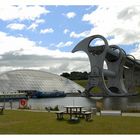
[0,110,140,134]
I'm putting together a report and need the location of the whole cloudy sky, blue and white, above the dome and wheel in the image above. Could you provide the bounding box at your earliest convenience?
[0,3,140,74]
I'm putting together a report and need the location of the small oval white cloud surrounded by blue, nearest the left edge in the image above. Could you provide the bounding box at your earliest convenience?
[6,23,26,30]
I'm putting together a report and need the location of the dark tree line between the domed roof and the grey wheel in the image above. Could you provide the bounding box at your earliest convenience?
[60,71,89,80]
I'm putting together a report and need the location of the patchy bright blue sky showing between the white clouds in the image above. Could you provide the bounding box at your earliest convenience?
[0,6,96,51]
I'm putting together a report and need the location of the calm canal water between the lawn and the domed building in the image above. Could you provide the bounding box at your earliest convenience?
[0,95,140,110]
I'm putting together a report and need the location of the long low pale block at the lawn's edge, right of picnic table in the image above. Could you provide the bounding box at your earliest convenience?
[100,110,122,116]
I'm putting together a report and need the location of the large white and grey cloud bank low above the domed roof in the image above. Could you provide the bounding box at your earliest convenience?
[0,32,89,74]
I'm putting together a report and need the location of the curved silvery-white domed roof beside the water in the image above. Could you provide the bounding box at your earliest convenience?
[0,69,84,93]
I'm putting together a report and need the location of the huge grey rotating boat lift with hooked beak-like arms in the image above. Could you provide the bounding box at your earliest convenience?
[72,35,140,96]
